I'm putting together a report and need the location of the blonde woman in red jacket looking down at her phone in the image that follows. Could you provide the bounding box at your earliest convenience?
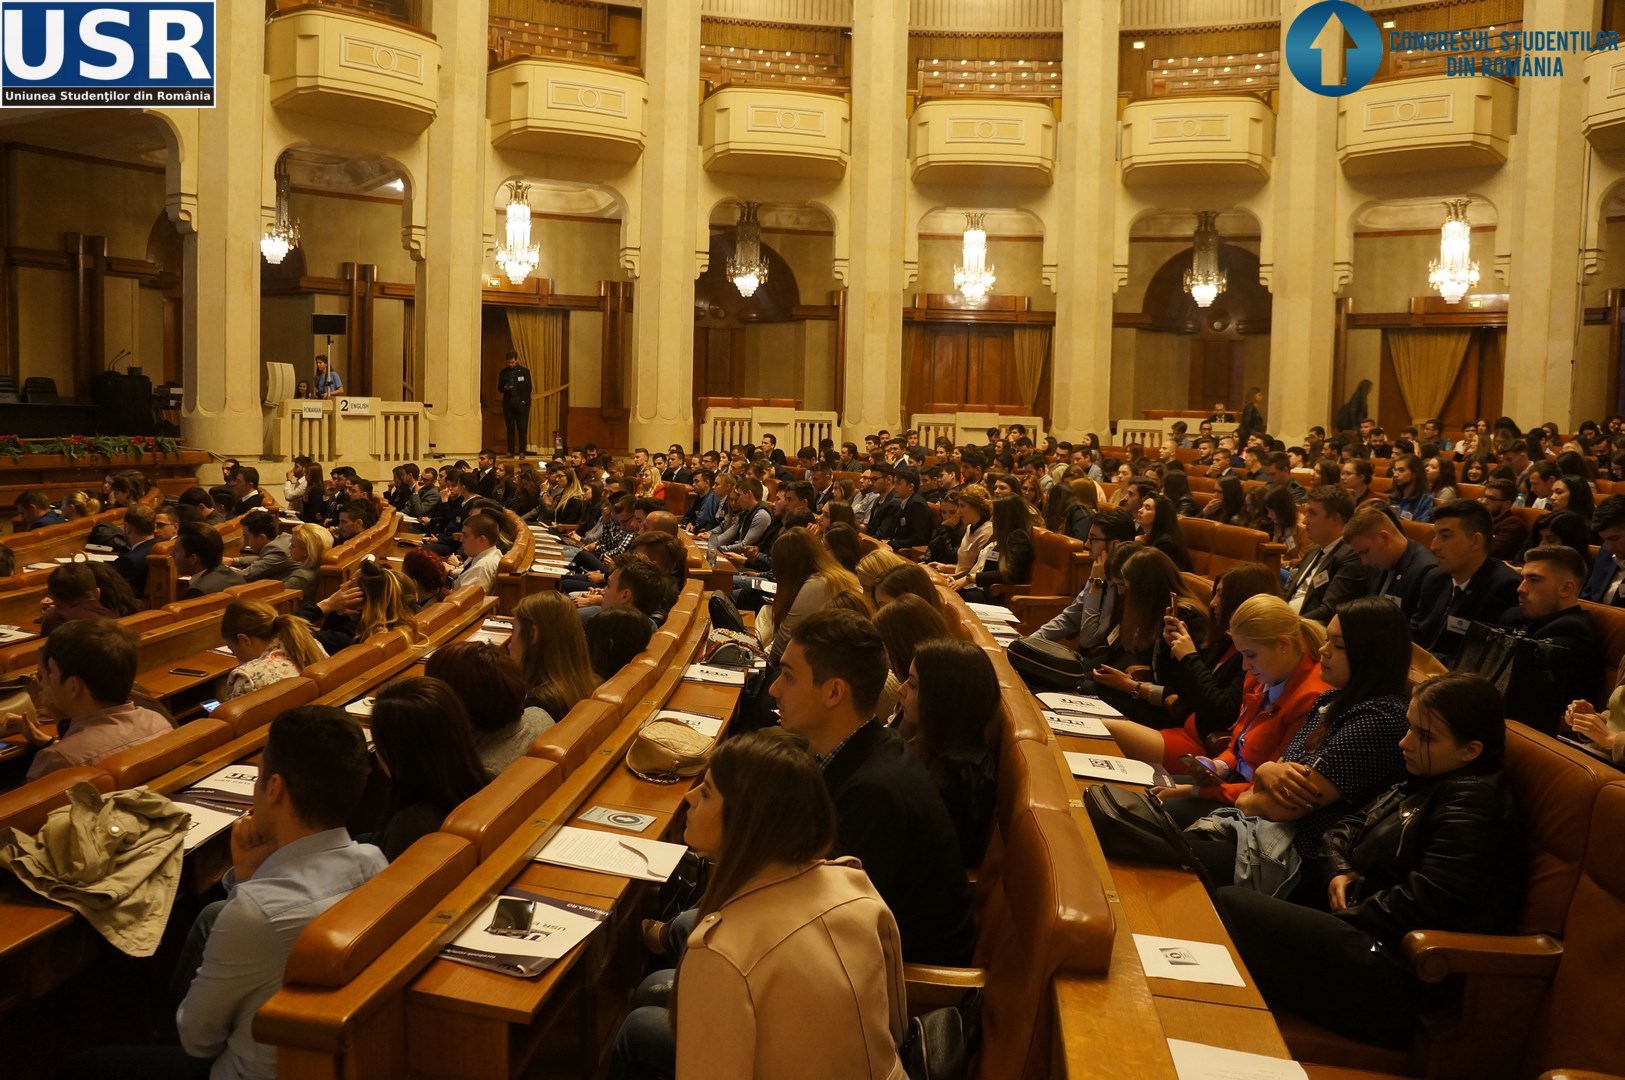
[1150,594,1328,820]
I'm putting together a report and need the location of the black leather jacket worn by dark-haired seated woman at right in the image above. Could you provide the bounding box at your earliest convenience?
[1321,770,1524,945]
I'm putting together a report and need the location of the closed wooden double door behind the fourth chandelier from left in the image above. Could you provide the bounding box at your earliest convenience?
[907,323,1024,414]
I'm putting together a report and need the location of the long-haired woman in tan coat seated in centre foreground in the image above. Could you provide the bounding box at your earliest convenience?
[609,734,907,1080]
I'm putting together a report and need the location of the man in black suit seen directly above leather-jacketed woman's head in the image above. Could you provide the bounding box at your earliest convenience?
[1415,499,1519,664]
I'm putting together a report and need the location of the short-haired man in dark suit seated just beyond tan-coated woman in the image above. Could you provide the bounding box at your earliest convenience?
[772,607,977,965]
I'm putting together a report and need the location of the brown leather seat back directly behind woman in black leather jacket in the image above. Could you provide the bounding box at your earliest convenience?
[1505,721,1619,939]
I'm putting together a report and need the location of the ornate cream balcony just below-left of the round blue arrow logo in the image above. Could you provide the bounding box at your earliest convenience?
[1118,94,1276,184]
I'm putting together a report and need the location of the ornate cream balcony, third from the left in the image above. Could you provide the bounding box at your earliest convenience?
[700,86,852,180]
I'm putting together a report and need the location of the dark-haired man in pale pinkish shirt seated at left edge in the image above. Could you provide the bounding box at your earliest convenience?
[0,619,171,780]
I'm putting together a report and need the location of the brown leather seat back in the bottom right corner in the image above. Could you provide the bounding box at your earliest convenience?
[1524,781,1625,1077]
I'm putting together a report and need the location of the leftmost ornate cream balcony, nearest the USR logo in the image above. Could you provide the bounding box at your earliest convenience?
[265,8,440,132]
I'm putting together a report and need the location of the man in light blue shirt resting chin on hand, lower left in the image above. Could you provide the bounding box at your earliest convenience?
[60,705,385,1080]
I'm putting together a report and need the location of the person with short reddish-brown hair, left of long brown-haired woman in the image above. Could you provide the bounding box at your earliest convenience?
[423,642,556,776]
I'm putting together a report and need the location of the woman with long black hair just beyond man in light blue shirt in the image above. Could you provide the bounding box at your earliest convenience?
[372,676,486,862]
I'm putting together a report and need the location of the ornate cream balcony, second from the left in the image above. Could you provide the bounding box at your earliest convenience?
[486,58,648,161]
